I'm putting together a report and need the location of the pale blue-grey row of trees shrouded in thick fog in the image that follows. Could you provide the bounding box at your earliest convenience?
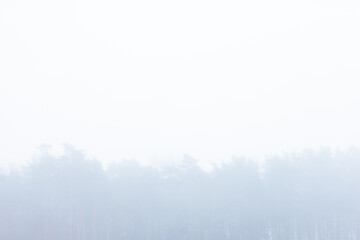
[0,147,360,240]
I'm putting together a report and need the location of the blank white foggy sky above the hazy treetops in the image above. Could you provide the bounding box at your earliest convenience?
[0,0,360,171]
